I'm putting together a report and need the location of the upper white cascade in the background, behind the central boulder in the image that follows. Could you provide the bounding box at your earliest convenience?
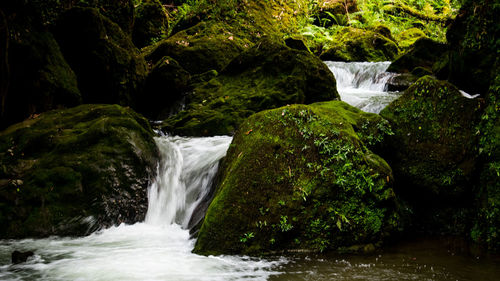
[325,61,399,113]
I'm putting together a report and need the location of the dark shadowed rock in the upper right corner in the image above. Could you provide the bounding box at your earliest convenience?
[438,0,500,95]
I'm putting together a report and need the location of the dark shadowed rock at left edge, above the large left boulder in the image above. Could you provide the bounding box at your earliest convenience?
[0,30,82,128]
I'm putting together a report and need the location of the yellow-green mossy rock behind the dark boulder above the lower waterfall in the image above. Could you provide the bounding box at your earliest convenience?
[144,21,252,74]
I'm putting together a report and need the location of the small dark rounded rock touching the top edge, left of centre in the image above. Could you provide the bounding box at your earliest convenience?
[132,0,168,48]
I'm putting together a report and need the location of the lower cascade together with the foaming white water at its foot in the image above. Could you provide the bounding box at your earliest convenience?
[0,137,285,281]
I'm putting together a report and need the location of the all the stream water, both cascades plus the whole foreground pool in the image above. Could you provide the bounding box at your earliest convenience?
[0,62,500,281]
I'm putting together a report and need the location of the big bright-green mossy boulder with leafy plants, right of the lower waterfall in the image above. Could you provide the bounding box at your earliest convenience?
[194,101,402,255]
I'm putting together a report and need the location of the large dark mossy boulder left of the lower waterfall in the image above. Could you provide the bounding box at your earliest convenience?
[0,105,158,238]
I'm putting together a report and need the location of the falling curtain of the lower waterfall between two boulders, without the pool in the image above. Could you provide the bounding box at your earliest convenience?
[146,136,232,228]
